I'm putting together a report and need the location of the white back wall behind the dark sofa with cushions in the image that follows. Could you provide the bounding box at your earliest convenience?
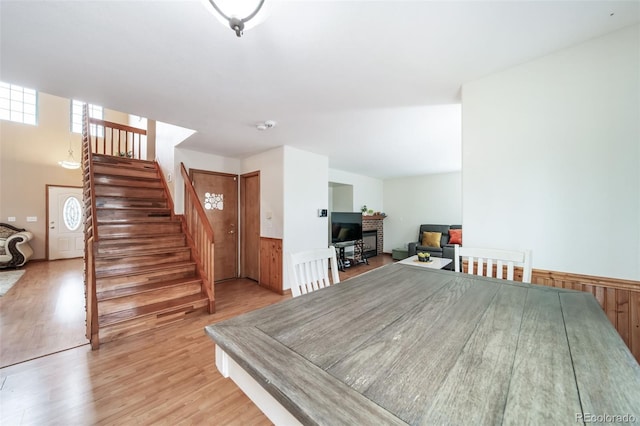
[383,172,464,253]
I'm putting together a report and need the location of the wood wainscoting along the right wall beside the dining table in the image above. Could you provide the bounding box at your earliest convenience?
[520,269,640,362]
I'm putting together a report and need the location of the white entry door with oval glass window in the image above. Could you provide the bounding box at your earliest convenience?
[47,186,84,260]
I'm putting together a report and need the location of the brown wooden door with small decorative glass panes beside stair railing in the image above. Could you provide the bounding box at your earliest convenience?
[189,169,238,281]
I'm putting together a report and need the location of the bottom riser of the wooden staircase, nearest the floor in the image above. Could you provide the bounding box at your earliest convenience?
[99,300,207,343]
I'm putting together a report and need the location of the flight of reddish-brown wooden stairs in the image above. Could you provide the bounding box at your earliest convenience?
[85,154,213,348]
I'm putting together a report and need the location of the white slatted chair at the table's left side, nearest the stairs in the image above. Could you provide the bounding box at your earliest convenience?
[286,247,340,297]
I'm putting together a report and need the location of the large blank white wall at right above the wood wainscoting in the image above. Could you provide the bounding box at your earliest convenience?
[462,25,640,280]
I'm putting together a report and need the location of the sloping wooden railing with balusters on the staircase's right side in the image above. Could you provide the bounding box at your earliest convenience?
[180,163,215,313]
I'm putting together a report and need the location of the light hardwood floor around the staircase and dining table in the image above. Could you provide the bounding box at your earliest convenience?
[0,255,392,425]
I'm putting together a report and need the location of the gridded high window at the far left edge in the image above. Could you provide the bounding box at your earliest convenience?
[0,81,38,125]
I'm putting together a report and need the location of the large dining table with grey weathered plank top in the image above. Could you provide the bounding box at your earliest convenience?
[205,264,640,425]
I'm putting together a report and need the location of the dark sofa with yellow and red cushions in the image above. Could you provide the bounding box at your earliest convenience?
[408,224,462,270]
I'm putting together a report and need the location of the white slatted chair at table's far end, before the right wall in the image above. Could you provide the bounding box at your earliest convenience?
[453,244,531,283]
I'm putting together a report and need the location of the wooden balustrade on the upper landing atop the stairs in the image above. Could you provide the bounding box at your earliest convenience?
[89,118,147,160]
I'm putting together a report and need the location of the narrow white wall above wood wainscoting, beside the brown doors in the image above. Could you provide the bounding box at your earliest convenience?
[241,147,284,238]
